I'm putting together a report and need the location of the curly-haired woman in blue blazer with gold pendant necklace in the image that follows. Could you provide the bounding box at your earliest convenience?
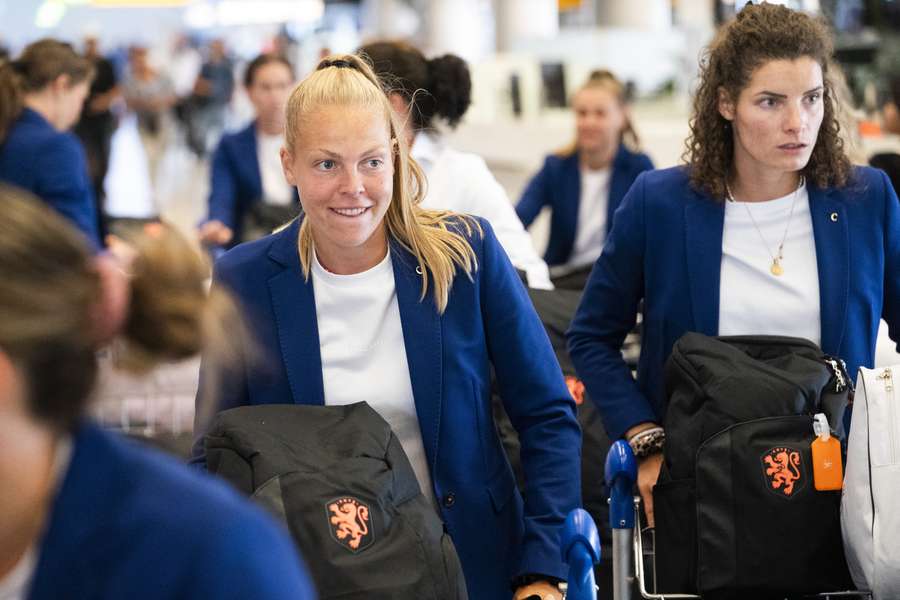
[568,4,900,522]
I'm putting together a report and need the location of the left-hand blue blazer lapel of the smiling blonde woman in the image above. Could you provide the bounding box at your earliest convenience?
[269,219,325,405]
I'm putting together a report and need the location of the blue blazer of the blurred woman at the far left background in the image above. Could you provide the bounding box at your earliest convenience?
[0,108,101,249]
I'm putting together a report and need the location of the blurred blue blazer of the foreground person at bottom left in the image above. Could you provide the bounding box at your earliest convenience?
[27,425,316,600]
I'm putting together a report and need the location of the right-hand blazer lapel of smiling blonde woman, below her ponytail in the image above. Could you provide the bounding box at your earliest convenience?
[391,243,444,477]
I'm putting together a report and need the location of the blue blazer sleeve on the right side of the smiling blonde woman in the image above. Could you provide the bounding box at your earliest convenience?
[479,223,581,579]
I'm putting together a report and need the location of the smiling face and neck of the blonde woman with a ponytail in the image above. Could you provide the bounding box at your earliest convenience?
[281,106,394,274]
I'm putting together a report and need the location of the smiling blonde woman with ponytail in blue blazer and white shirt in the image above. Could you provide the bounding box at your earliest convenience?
[195,55,581,600]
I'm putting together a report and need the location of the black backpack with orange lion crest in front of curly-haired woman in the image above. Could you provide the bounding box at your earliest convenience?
[653,333,853,599]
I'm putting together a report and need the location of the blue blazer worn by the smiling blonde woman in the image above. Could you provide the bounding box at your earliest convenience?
[195,219,581,600]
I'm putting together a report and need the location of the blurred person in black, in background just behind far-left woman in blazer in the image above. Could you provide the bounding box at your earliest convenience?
[75,36,119,238]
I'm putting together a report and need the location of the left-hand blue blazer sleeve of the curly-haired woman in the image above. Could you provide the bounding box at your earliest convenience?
[566,175,657,440]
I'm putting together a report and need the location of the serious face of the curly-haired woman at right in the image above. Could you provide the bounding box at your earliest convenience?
[719,57,825,182]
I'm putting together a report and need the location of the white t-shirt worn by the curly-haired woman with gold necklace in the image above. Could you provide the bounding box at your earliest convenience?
[719,185,822,344]
